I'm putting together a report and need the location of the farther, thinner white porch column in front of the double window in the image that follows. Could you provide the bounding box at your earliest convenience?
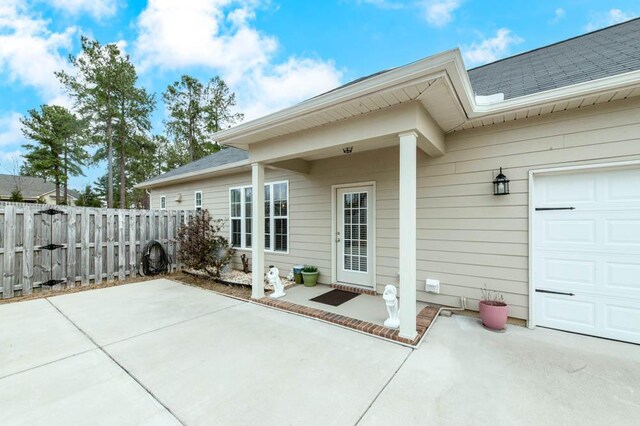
[251,163,264,299]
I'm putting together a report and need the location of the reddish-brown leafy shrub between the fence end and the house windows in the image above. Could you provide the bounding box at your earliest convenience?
[178,210,235,278]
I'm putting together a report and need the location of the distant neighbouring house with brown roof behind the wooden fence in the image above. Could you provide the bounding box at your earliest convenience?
[0,174,79,205]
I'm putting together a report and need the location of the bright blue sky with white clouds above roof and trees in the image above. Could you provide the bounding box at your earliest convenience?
[0,0,640,188]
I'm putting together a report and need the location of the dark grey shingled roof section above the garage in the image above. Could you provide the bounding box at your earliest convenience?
[468,18,640,99]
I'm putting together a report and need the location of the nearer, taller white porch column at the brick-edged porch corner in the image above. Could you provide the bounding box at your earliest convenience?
[398,132,418,339]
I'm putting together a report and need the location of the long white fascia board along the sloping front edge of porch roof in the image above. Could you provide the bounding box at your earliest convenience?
[212,49,462,145]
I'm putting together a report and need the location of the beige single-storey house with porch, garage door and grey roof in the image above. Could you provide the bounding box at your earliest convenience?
[139,19,640,343]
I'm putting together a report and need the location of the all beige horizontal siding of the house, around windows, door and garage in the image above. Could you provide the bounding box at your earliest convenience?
[151,95,640,318]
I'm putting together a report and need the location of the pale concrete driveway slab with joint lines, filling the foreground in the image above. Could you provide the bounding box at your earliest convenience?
[0,280,640,425]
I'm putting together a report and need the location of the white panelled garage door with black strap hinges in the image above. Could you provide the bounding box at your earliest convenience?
[533,167,640,343]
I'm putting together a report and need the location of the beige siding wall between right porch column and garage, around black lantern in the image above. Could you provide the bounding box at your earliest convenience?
[417,95,640,318]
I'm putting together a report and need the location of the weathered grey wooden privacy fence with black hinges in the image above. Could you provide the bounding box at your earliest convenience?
[0,203,195,299]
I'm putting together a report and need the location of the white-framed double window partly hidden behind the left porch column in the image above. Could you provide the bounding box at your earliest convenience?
[229,181,289,252]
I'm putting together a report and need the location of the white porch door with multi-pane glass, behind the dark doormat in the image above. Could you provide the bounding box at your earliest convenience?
[335,186,375,287]
